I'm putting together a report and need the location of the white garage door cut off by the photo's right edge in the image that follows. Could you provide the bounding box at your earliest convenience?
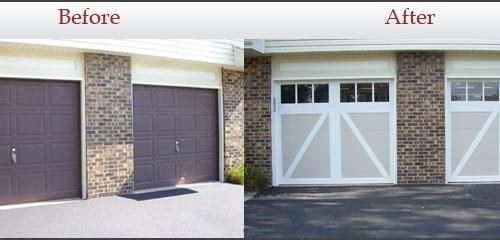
[446,79,500,182]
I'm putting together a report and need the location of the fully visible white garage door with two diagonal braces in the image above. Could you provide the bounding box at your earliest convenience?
[275,80,395,184]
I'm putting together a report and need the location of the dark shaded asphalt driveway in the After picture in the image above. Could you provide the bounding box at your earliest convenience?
[245,184,500,238]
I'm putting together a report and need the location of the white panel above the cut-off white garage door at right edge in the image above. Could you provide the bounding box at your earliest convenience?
[445,53,500,78]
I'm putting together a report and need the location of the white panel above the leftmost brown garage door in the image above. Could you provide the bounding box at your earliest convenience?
[0,46,83,80]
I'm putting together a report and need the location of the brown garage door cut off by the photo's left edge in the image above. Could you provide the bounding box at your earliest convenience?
[0,79,81,204]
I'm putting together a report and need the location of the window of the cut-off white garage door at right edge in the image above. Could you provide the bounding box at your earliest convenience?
[451,80,499,102]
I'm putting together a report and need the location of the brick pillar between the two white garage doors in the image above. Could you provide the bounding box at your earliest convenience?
[397,52,445,184]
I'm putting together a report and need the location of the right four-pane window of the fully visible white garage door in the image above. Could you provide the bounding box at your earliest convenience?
[340,82,389,103]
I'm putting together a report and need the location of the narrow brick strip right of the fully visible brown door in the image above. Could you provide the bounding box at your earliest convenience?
[222,69,245,170]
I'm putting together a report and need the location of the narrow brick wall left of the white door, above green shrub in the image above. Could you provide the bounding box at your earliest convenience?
[245,57,272,183]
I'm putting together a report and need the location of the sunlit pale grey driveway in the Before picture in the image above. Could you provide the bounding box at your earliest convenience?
[0,183,243,238]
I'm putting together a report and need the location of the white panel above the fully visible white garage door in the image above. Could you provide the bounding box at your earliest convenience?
[272,54,396,80]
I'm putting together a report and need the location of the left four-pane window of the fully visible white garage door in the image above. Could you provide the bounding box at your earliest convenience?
[281,84,329,104]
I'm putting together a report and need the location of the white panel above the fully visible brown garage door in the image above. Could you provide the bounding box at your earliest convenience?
[132,58,222,88]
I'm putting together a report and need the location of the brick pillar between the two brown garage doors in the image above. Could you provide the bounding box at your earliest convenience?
[84,53,134,198]
